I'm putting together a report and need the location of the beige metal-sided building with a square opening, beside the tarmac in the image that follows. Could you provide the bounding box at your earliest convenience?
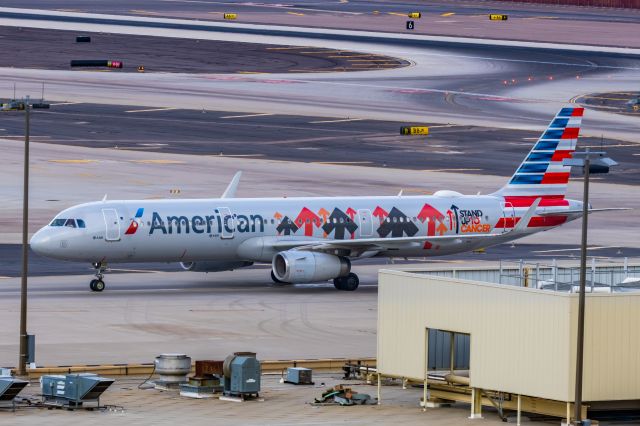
[378,270,640,422]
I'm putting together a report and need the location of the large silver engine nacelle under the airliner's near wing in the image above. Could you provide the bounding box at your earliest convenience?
[271,250,351,283]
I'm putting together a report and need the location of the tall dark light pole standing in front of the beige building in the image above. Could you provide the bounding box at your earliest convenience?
[562,148,618,425]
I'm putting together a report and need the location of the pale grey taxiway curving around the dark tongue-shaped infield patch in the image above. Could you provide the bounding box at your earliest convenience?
[0,9,640,142]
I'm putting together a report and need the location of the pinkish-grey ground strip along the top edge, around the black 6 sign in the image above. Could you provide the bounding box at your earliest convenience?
[3,0,640,47]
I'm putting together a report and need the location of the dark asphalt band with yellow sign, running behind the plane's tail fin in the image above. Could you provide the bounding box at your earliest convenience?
[0,104,640,185]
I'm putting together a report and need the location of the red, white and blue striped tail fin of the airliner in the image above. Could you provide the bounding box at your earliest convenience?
[493,107,584,207]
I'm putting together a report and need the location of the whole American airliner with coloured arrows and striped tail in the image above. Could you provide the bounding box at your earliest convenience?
[31,107,600,291]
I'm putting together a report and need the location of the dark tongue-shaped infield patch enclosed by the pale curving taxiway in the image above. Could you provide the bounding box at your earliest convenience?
[0,27,409,74]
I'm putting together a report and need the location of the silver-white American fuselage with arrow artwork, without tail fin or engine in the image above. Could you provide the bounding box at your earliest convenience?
[32,193,574,262]
